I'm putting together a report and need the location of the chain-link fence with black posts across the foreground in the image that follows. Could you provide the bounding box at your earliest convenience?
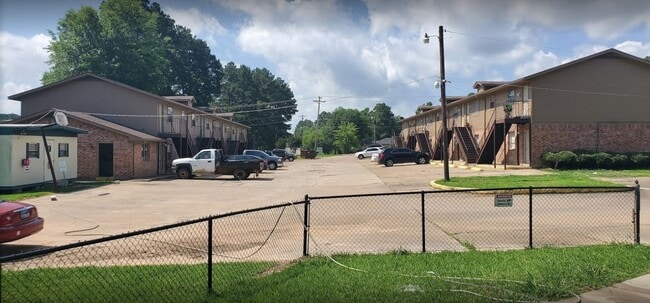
[0,186,640,302]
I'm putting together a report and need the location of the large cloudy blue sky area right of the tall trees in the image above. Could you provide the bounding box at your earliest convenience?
[200,0,650,129]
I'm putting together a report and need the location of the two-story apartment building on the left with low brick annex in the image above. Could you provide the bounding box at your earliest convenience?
[9,73,249,179]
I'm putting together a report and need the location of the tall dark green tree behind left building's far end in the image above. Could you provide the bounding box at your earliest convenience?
[217,62,297,149]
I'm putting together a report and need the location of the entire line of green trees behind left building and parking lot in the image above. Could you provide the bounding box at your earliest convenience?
[41,0,401,152]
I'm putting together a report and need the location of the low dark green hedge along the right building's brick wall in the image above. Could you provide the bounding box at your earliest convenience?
[542,151,650,169]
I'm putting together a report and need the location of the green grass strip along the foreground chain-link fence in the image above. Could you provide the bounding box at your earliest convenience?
[1,244,650,302]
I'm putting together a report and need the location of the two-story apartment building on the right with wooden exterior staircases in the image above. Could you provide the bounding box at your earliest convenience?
[398,49,650,167]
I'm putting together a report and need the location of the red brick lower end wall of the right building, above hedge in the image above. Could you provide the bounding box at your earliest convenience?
[531,122,650,167]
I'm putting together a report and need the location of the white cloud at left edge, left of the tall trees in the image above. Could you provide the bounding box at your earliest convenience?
[0,32,50,114]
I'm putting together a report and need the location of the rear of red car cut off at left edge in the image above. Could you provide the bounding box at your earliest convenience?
[0,200,44,243]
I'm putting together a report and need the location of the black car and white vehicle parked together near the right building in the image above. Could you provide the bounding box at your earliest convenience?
[354,147,431,167]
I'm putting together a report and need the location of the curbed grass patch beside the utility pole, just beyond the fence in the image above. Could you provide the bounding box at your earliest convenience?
[436,171,631,189]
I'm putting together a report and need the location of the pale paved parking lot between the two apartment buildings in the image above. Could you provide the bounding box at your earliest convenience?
[0,155,650,255]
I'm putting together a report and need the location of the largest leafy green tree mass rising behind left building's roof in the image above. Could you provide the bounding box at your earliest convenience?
[41,0,222,105]
